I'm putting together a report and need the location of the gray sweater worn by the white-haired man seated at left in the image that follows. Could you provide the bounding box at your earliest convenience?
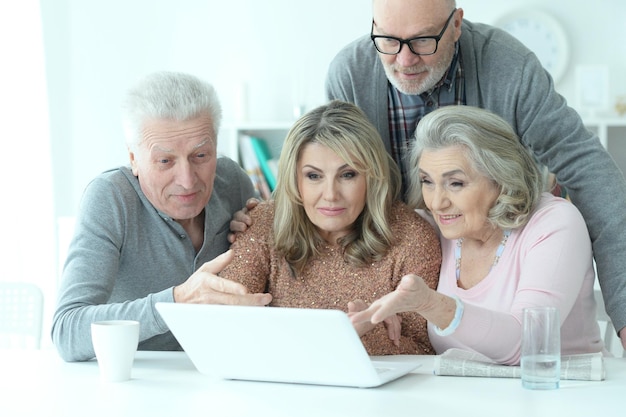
[52,158,254,361]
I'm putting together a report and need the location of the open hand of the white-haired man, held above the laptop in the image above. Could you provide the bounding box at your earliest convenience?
[174,250,272,306]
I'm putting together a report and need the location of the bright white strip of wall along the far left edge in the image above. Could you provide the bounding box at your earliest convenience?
[0,0,57,344]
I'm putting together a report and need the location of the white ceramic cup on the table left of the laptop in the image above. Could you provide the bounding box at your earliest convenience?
[91,320,139,382]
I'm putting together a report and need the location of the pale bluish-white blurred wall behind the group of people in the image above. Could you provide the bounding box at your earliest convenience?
[41,0,626,216]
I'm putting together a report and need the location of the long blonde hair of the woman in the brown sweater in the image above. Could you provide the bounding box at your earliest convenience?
[273,100,400,274]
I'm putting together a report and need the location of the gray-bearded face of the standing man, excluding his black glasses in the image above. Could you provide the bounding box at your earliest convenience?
[372,0,463,95]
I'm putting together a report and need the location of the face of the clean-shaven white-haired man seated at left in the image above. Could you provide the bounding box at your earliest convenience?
[129,116,217,221]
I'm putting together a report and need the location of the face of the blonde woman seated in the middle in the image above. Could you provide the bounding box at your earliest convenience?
[297,143,367,244]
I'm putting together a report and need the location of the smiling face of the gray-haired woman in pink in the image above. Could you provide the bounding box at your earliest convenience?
[419,146,500,240]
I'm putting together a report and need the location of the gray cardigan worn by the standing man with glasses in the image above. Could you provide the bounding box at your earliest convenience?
[326,21,626,330]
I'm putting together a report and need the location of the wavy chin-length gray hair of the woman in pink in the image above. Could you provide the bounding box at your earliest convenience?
[408,106,544,229]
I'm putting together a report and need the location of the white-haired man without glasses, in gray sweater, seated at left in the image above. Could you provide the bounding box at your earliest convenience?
[52,72,271,361]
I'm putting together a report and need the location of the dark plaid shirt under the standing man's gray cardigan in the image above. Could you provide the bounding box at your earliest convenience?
[387,44,465,195]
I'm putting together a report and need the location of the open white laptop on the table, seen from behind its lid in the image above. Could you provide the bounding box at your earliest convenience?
[156,303,420,388]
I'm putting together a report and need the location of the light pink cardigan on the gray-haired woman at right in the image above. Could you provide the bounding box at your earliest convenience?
[429,193,604,365]
